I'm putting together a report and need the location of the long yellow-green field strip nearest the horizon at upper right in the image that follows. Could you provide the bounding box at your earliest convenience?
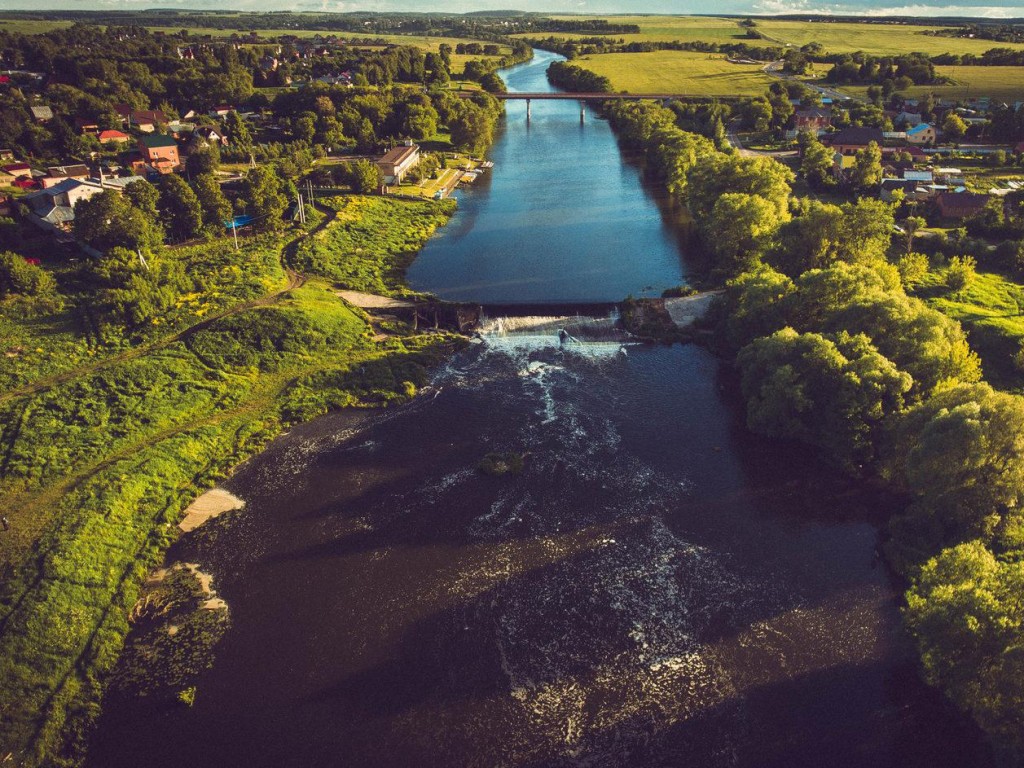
[540,16,1024,55]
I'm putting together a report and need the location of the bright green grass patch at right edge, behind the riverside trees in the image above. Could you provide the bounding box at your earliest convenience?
[916,269,1024,389]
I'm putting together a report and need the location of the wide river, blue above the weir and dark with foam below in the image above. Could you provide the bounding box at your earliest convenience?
[89,51,986,768]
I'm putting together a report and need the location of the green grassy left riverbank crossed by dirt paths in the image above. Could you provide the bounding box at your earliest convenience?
[0,198,464,766]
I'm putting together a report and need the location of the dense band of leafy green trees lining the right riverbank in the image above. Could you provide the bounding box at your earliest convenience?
[605,97,1024,762]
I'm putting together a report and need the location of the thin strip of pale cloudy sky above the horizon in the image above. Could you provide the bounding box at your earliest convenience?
[0,0,1024,18]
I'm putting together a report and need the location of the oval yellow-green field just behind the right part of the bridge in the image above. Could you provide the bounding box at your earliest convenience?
[572,50,772,96]
